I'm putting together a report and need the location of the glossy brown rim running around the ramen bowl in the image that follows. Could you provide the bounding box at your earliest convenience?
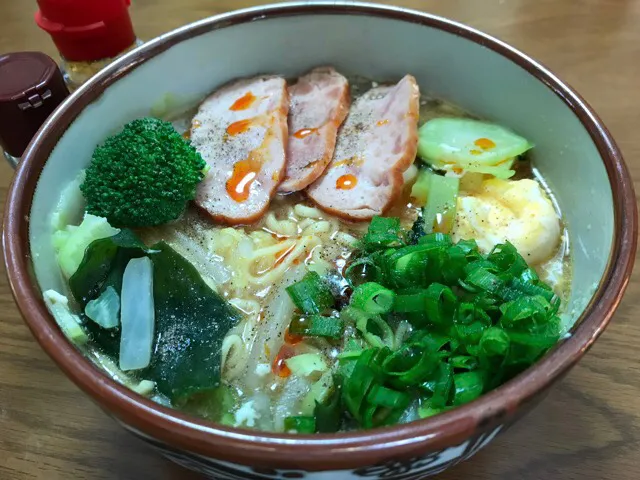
[3,1,638,470]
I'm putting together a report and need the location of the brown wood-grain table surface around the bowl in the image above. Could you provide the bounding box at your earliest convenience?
[0,0,640,480]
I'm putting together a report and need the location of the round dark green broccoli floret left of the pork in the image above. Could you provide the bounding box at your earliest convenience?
[80,118,206,228]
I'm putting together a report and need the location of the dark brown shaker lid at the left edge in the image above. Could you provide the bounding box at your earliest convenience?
[0,52,69,157]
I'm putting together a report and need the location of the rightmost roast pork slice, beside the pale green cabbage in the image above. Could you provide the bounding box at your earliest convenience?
[307,75,420,220]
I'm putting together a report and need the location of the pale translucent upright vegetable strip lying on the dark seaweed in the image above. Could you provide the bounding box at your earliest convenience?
[120,257,155,371]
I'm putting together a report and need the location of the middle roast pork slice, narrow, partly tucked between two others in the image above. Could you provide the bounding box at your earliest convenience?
[278,67,350,193]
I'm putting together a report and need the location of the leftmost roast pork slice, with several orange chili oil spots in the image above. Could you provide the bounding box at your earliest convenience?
[191,77,289,225]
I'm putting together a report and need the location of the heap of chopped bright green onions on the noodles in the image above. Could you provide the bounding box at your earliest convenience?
[328,215,561,431]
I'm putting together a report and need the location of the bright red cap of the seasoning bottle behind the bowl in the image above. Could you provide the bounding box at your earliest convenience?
[35,0,136,62]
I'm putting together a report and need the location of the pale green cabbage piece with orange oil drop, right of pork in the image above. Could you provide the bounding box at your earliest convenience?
[418,118,533,178]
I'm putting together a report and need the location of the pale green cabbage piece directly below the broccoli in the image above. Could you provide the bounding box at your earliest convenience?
[53,214,119,278]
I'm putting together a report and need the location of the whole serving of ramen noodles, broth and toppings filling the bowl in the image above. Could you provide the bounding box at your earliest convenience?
[45,69,571,433]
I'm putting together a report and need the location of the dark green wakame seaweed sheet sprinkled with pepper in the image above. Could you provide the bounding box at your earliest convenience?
[69,230,240,405]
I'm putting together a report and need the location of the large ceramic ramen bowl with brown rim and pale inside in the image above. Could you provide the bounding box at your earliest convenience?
[3,1,637,480]
